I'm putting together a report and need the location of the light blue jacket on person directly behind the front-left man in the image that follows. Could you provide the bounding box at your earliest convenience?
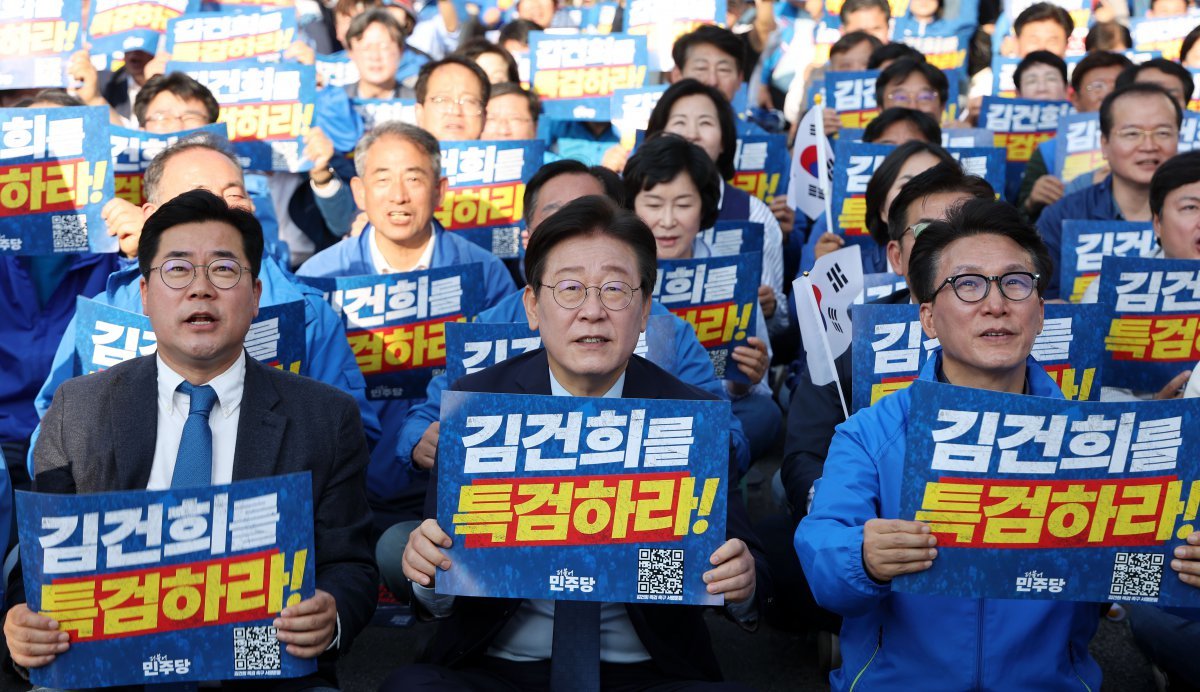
[30,255,379,453]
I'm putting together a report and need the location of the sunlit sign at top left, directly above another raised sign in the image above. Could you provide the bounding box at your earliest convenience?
[166,8,296,62]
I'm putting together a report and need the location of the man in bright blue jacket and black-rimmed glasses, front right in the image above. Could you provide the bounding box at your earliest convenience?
[796,199,1200,690]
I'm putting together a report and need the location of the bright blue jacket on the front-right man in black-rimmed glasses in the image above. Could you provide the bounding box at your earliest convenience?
[796,350,1100,692]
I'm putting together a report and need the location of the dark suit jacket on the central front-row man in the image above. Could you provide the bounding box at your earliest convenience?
[414,349,770,680]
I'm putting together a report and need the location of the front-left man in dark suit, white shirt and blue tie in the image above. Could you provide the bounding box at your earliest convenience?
[5,189,378,690]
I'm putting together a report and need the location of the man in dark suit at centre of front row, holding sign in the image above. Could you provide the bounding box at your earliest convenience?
[383,197,769,691]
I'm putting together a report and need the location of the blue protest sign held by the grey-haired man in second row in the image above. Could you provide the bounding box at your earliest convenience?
[300,263,484,399]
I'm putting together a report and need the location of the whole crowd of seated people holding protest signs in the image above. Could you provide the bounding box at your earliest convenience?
[0,0,1200,691]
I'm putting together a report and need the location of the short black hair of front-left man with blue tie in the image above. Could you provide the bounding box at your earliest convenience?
[138,189,263,281]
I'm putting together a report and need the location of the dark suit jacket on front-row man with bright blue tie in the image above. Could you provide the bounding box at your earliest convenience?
[15,356,378,685]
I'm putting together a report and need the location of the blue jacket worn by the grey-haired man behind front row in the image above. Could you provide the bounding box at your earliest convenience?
[298,221,515,503]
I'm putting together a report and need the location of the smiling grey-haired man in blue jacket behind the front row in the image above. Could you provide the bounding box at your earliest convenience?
[299,121,515,526]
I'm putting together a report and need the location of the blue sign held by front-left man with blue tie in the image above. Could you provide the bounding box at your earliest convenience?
[17,474,317,690]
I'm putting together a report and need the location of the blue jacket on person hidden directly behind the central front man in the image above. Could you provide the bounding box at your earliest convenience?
[397,289,750,470]
